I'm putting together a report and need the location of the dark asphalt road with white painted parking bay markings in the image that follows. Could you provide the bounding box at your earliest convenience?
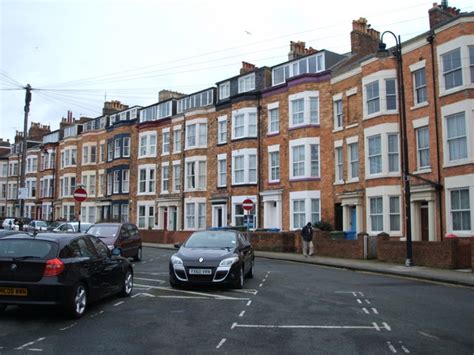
[0,248,474,355]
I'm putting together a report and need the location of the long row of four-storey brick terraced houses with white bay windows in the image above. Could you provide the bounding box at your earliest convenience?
[0,4,474,241]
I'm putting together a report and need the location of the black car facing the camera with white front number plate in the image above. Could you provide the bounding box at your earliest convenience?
[169,230,255,288]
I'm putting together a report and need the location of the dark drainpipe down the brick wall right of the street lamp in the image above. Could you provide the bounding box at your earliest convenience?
[426,31,444,240]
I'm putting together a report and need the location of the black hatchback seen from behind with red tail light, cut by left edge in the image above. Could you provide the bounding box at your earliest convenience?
[0,233,133,318]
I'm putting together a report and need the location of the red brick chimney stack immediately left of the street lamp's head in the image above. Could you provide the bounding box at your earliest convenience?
[351,17,380,56]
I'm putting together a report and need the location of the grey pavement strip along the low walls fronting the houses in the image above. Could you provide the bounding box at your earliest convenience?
[143,243,474,288]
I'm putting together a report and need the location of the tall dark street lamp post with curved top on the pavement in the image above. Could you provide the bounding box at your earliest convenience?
[377,31,414,266]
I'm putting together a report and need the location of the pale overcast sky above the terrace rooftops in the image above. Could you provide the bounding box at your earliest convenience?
[0,0,474,141]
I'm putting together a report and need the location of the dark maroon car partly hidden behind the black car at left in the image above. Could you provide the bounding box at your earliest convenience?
[87,223,142,261]
